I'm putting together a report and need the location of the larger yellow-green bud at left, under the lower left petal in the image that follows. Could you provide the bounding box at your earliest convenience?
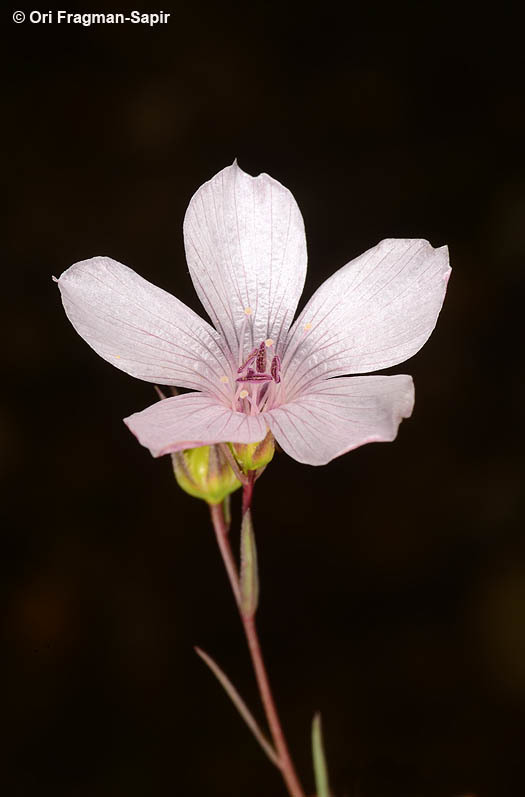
[171,445,241,504]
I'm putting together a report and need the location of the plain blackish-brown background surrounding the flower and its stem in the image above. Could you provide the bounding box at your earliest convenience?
[4,0,525,797]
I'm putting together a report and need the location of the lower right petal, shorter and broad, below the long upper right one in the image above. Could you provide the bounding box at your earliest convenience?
[264,375,414,465]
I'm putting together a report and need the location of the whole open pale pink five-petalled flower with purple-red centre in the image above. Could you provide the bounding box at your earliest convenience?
[58,162,450,465]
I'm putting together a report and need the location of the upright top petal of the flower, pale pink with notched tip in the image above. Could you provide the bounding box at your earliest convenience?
[184,162,306,356]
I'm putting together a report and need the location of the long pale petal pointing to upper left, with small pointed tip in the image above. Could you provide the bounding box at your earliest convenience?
[58,257,230,398]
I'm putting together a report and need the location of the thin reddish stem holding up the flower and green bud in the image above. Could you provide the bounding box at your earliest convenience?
[206,494,305,797]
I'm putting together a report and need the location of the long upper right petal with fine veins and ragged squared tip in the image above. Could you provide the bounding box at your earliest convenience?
[283,238,450,397]
